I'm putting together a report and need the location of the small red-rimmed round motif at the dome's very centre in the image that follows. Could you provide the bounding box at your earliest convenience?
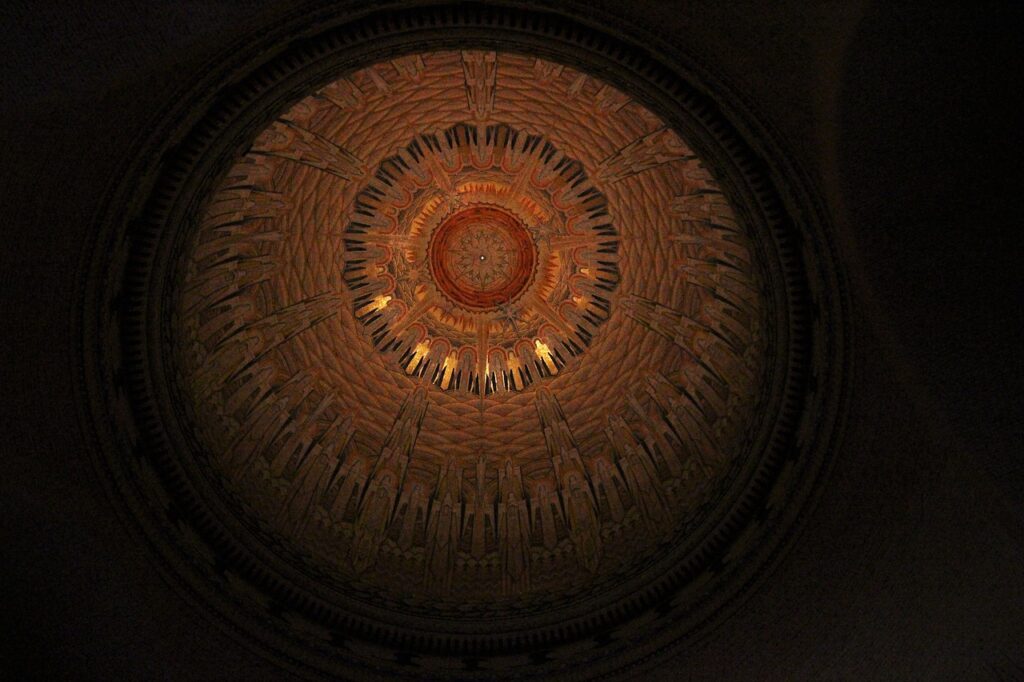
[428,201,537,310]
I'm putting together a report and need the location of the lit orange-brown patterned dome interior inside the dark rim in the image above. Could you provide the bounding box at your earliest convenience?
[172,51,767,606]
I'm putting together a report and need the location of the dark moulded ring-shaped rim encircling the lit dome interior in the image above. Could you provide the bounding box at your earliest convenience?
[76,5,850,677]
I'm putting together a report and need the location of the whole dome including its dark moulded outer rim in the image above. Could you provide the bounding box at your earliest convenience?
[83,5,844,679]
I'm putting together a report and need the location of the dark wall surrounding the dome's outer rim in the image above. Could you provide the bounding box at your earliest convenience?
[0,0,1024,680]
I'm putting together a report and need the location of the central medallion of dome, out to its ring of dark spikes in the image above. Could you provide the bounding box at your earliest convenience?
[344,119,620,394]
